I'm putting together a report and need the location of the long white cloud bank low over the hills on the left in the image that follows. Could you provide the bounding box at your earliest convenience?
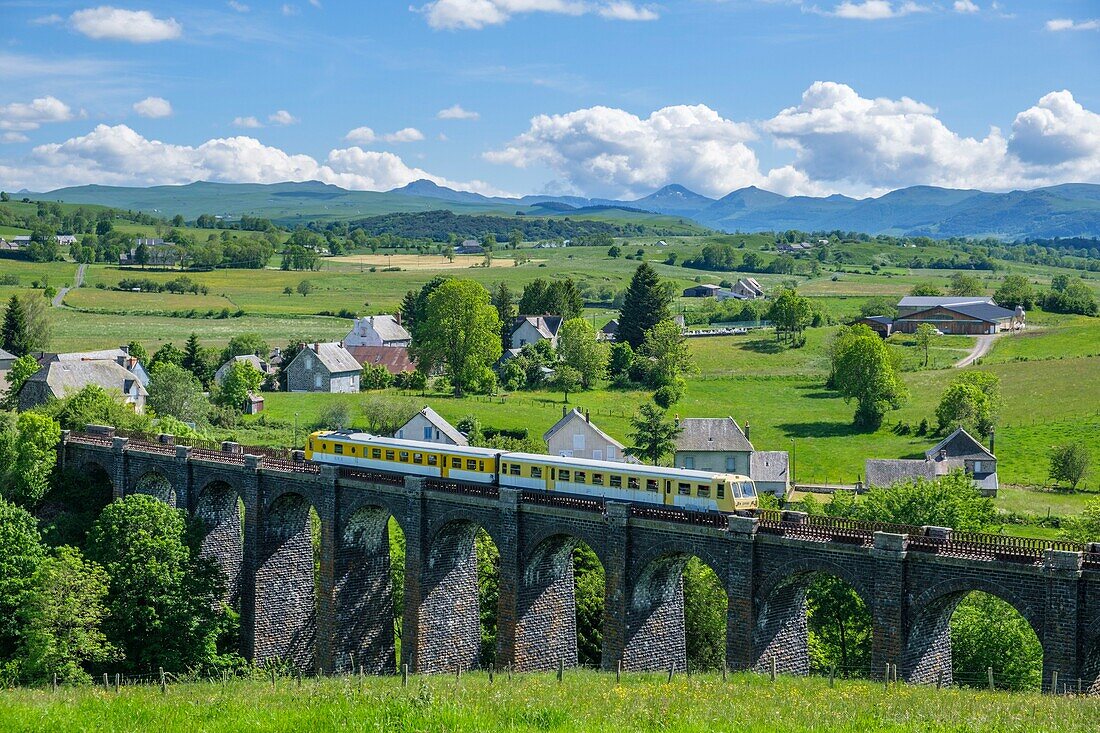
[0,124,503,195]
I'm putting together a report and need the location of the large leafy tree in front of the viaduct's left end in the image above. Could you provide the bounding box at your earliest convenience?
[88,494,224,672]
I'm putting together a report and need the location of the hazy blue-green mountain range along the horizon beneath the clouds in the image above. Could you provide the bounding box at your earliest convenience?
[30,180,1100,240]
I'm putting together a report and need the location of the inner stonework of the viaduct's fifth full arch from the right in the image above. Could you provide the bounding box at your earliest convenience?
[416,512,499,674]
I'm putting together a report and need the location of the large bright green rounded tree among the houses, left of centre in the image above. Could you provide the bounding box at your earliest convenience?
[413,280,502,396]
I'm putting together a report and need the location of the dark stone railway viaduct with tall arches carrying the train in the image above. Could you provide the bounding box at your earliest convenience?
[62,428,1100,693]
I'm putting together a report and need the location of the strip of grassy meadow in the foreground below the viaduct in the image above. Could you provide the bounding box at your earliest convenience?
[0,670,1100,733]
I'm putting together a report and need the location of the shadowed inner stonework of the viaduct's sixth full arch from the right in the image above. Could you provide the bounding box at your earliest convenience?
[333,504,404,675]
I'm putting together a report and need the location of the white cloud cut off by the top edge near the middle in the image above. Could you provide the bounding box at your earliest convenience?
[410,0,659,30]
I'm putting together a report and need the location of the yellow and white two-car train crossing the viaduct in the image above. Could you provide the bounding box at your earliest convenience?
[306,430,757,512]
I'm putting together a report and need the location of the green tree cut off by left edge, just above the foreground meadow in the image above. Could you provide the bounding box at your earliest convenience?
[0,496,46,667]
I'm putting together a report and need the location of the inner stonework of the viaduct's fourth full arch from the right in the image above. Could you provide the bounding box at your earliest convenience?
[514,530,606,671]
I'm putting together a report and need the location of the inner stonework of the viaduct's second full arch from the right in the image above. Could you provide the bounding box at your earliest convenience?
[752,557,873,675]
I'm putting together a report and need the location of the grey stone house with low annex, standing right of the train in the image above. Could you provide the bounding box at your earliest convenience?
[864,428,999,496]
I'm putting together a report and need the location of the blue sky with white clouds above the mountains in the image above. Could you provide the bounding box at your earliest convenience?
[0,0,1100,197]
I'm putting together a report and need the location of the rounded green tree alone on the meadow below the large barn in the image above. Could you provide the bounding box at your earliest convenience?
[834,329,908,429]
